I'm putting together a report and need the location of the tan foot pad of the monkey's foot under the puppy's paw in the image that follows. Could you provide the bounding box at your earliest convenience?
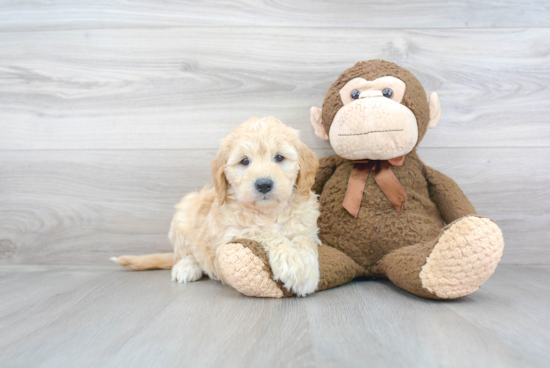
[218,243,292,298]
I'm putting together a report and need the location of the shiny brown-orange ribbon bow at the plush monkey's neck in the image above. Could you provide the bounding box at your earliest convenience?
[343,155,407,217]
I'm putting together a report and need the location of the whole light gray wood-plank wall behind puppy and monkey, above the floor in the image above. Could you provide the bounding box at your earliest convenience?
[0,0,550,264]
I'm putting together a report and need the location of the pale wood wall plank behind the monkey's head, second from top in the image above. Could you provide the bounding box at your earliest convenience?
[0,27,550,150]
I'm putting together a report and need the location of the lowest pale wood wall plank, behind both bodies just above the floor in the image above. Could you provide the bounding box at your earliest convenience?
[0,148,550,264]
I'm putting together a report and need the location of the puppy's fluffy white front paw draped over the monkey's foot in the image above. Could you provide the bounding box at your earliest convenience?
[269,240,319,296]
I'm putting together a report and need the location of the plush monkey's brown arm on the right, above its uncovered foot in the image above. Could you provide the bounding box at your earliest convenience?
[424,166,476,224]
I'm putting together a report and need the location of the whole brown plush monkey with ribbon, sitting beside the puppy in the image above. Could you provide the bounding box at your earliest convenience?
[219,60,504,299]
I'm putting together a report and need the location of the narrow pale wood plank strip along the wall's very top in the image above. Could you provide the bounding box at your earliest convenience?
[0,0,550,31]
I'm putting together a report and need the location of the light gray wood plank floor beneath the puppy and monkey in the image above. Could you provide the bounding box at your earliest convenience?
[0,265,550,367]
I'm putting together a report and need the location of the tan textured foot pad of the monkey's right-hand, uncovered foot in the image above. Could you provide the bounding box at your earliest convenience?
[420,216,504,299]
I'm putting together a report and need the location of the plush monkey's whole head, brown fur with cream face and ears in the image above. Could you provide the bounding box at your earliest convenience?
[311,60,440,160]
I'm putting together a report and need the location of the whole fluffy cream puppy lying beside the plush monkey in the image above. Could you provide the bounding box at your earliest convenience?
[111,117,321,296]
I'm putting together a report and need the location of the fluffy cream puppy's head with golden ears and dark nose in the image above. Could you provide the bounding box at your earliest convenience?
[212,117,318,209]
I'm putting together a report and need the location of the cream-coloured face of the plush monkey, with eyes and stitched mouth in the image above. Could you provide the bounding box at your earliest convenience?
[329,76,418,160]
